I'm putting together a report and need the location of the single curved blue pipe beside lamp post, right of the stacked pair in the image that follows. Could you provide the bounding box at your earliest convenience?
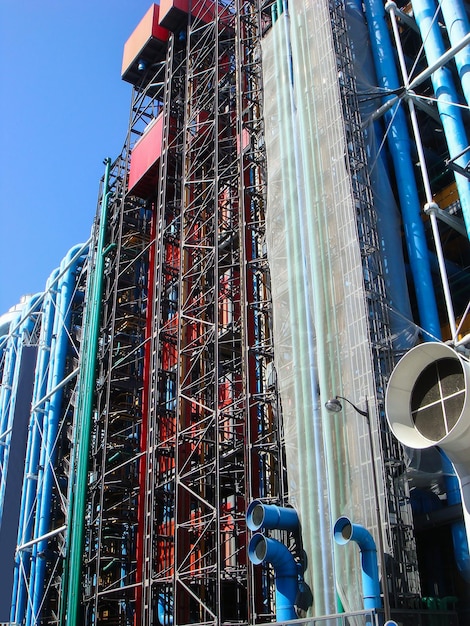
[333,517,382,610]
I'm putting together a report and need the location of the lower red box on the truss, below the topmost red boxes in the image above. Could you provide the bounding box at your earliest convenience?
[129,112,163,199]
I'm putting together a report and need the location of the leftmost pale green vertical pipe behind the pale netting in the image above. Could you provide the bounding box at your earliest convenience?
[268,15,324,611]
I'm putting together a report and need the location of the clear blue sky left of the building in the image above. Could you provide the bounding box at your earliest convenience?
[0,0,152,315]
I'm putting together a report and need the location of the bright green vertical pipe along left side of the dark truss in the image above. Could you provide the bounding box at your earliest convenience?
[60,158,111,626]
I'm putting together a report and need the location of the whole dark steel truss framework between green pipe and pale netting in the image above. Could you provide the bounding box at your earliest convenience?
[78,2,285,625]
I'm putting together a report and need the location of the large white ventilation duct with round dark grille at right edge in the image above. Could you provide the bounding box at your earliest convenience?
[385,342,470,546]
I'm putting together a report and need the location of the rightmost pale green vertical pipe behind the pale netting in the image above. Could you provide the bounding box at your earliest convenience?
[291,3,352,604]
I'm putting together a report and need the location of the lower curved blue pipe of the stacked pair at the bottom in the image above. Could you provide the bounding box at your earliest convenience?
[248,533,299,622]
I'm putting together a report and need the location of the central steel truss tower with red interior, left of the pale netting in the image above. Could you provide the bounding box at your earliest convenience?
[142,2,282,624]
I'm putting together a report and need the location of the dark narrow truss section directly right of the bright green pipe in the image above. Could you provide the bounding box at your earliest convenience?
[83,155,151,624]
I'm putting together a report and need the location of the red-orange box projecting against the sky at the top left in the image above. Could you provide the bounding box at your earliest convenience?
[121,4,170,85]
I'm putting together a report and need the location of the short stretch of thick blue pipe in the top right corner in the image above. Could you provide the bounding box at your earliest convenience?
[441,0,470,104]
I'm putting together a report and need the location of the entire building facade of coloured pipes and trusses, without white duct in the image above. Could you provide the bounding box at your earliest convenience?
[0,0,470,626]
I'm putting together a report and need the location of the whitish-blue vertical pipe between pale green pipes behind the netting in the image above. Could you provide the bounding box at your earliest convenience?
[283,13,334,615]
